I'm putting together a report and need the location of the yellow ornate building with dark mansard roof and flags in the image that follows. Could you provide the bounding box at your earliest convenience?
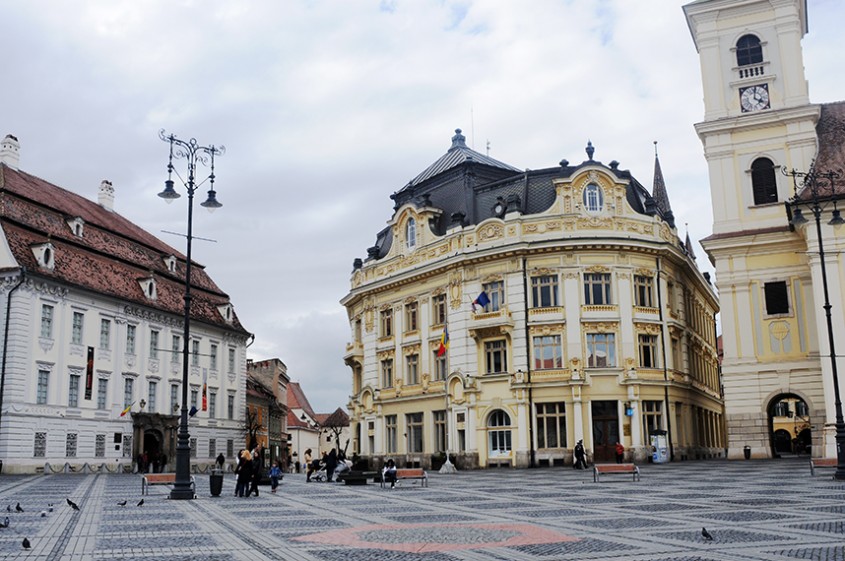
[342,130,724,468]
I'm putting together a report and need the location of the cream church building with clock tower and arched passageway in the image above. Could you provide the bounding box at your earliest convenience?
[684,0,845,458]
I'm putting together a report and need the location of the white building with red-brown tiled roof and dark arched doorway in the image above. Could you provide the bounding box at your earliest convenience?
[0,135,250,473]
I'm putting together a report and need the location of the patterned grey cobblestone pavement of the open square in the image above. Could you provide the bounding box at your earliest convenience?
[0,460,845,561]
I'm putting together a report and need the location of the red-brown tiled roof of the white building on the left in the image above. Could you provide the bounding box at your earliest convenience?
[0,162,247,334]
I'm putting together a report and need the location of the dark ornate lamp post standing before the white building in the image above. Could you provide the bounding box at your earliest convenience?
[158,129,226,500]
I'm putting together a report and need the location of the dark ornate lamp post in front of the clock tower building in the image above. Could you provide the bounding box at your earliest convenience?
[783,165,845,480]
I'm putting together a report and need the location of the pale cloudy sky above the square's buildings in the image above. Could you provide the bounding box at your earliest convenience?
[0,0,845,412]
